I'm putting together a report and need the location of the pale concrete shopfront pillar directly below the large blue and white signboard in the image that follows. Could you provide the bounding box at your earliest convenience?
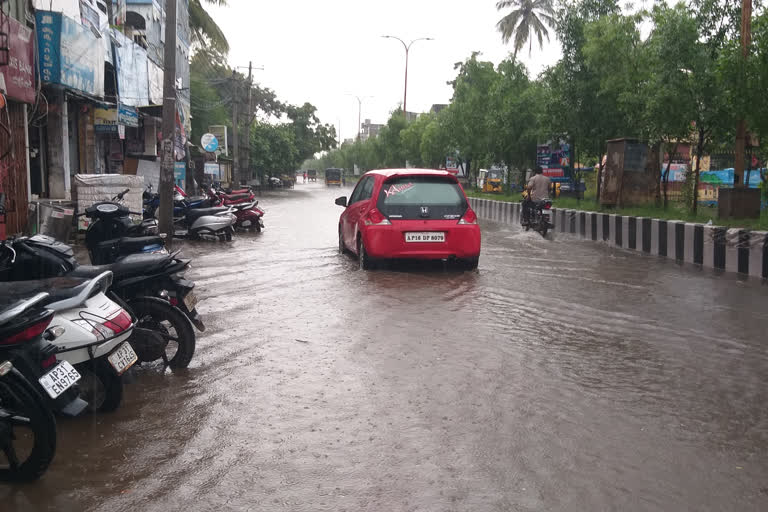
[47,93,72,199]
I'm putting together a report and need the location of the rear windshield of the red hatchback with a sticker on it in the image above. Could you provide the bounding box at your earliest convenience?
[376,176,467,219]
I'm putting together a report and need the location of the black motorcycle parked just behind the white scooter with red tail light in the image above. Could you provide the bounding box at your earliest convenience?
[0,235,198,368]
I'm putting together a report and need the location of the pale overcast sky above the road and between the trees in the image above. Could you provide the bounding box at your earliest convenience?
[207,0,559,140]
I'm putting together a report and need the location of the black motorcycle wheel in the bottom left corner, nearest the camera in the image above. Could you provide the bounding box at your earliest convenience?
[0,370,56,482]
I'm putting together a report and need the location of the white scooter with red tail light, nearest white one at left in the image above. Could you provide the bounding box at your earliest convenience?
[4,272,138,412]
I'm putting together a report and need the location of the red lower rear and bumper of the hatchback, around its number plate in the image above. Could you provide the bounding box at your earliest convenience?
[362,220,480,260]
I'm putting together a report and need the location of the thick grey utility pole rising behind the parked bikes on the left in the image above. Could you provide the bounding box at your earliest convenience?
[158,0,176,248]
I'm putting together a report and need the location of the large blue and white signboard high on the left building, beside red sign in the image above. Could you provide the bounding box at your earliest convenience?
[36,11,104,96]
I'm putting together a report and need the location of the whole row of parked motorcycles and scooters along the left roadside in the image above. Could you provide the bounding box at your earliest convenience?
[0,183,264,481]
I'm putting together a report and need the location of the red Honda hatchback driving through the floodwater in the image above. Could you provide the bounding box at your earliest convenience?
[336,169,480,270]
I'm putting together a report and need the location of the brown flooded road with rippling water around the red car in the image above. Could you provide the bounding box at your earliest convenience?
[6,185,768,512]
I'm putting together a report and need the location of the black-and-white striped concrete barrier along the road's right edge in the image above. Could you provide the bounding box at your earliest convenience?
[469,197,768,279]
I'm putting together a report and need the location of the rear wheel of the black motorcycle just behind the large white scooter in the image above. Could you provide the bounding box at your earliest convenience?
[130,297,195,368]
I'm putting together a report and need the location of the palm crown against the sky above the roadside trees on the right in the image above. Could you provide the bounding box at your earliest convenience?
[496,0,555,57]
